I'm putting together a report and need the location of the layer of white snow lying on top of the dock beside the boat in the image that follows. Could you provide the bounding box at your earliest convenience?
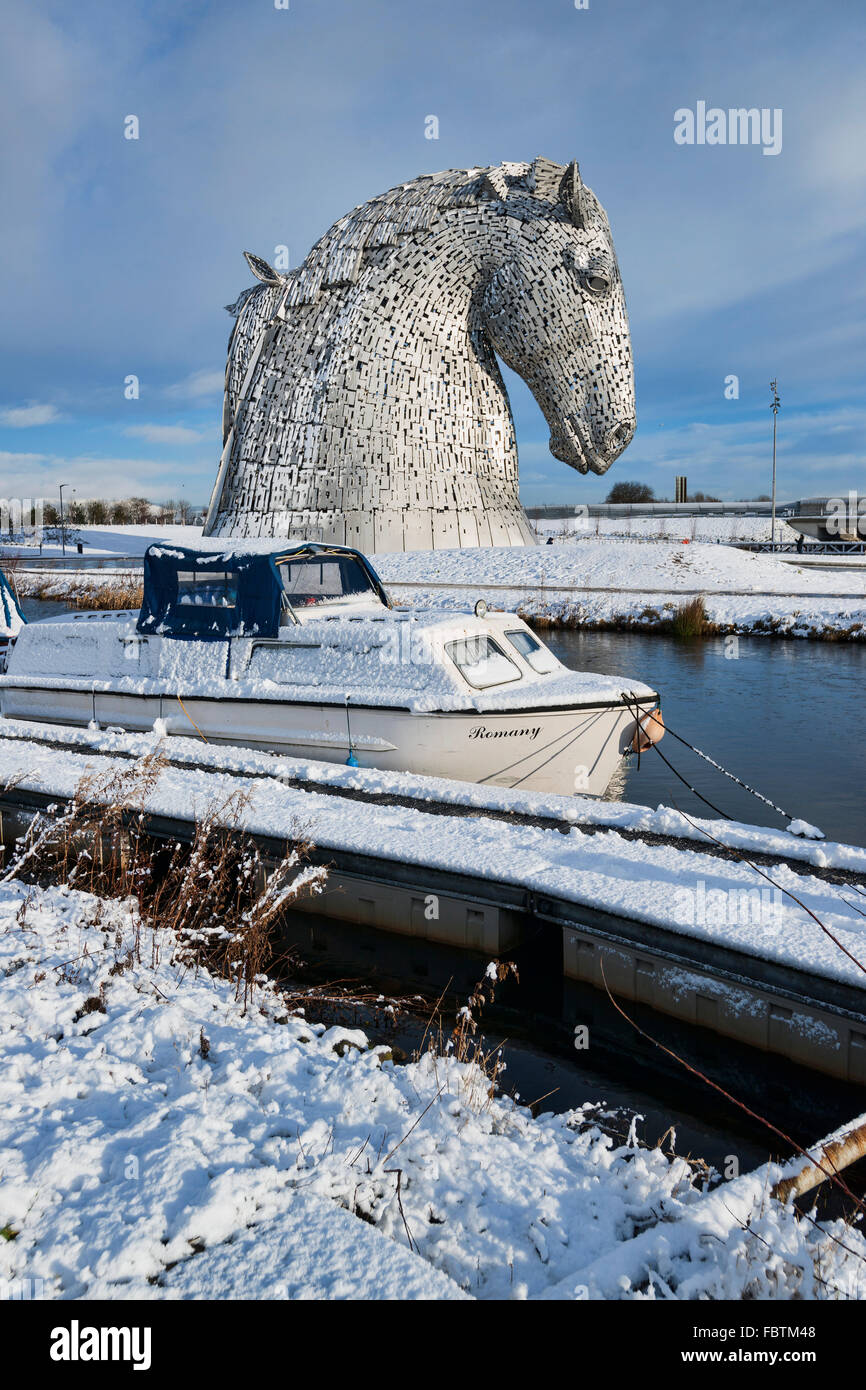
[0,720,866,988]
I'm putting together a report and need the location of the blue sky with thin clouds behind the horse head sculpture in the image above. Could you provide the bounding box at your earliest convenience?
[0,0,866,503]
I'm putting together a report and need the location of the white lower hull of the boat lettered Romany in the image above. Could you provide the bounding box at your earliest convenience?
[1,685,656,796]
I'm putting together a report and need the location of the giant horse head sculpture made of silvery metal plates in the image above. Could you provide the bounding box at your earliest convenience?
[206,158,635,550]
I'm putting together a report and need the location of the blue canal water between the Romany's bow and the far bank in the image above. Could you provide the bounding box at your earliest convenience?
[539,628,866,845]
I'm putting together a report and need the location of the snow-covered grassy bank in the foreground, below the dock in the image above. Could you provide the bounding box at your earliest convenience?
[0,880,866,1300]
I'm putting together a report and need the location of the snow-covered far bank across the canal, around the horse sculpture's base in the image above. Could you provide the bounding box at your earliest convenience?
[8,517,866,641]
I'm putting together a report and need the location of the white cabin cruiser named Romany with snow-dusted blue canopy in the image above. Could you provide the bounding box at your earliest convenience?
[0,539,662,795]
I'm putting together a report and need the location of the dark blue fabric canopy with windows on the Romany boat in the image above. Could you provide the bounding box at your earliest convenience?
[138,541,389,641]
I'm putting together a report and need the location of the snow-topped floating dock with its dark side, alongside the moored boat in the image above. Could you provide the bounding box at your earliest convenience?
[0,721,866,1083]
